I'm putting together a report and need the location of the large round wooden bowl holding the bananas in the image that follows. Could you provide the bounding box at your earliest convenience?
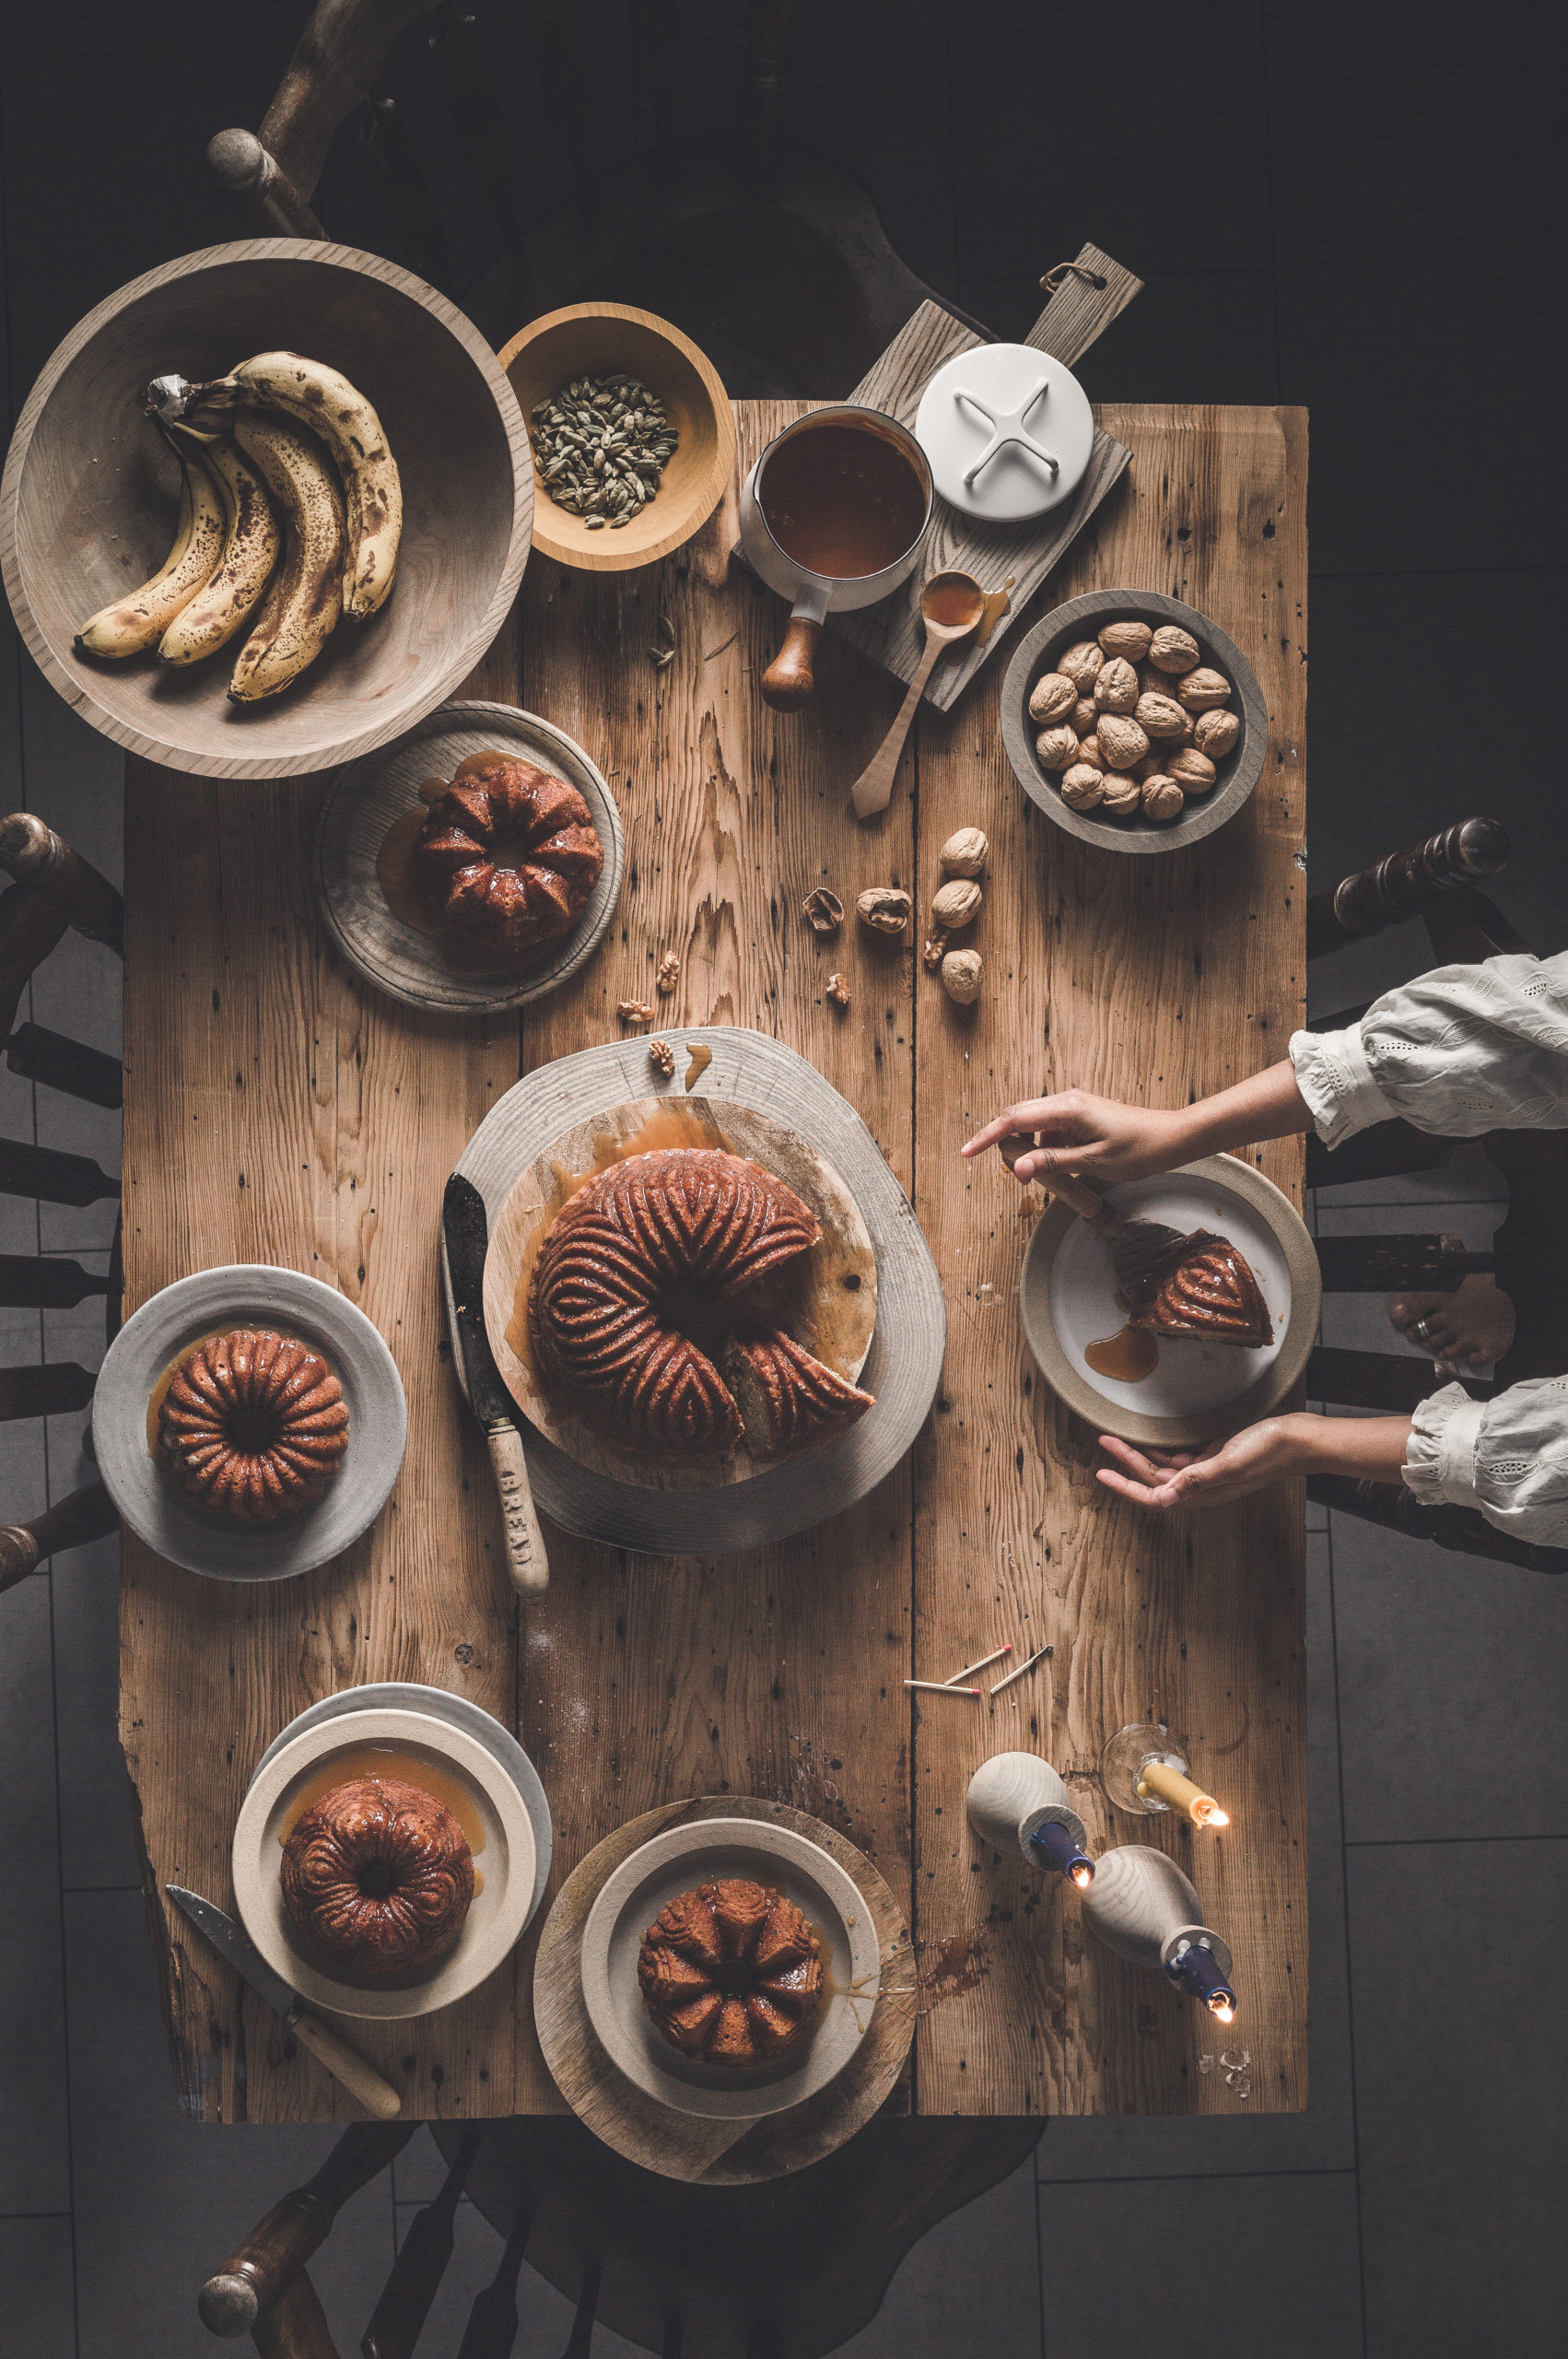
[0,239,532,779]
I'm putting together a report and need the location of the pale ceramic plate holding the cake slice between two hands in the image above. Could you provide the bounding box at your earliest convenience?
[1019,1156,1323,1449]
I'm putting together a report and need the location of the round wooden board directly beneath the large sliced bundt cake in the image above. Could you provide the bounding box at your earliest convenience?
[484,1095,877,1491]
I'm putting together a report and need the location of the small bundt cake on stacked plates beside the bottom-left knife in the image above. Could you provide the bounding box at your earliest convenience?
[283,1777,474,1979]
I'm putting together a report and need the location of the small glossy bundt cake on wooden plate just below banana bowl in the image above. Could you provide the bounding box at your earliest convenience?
[415,753,603,974]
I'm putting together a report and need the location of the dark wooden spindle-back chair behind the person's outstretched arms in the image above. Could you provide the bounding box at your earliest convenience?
[1306,818,1568,1571]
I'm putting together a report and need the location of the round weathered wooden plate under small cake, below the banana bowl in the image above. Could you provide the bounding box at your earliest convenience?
[311,703,627,1015]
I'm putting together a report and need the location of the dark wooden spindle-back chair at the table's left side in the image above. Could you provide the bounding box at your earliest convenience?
[0,812,125,1590]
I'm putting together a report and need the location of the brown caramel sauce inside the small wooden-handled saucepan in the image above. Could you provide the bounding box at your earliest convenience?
[757,417,927,581]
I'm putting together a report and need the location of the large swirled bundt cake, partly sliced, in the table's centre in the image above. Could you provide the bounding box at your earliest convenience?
[528,1146,870,1461]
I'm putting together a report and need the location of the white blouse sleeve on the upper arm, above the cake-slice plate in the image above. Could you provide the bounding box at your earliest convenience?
[1290,951,1568,1146]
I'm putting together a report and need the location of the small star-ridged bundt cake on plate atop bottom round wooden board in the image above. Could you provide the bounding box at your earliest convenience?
[637,1878,823,2064]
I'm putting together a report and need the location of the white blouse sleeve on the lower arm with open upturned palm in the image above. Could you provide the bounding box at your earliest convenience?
[1405,1375,1568,1547]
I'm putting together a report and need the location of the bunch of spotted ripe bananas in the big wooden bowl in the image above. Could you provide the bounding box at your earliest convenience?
[76,351,404,705]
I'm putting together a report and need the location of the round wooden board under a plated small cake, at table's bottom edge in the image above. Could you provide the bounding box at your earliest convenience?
[532,1793,915,2187]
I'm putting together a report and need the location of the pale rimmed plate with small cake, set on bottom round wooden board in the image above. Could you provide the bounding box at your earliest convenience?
[582,1819,882,2120]
